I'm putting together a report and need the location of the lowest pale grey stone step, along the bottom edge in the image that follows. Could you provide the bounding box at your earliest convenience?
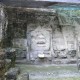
[17,70,80,80]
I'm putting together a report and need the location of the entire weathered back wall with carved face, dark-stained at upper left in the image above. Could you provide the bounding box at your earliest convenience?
[5,8,79,62]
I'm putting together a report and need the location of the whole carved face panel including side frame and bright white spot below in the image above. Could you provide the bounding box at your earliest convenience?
[27,24,52,60]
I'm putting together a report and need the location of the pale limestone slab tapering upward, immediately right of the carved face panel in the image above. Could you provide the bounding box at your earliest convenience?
[53,27,66,50]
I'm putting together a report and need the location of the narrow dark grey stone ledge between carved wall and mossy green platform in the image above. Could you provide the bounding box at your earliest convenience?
[16,58,77,65]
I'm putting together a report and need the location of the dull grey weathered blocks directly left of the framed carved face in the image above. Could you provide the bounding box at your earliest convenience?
[12,38,27,59]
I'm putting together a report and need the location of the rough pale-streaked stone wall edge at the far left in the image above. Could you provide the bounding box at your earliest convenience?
[0,4,8,47]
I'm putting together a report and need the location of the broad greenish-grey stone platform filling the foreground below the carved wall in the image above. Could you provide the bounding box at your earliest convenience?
[16,64,80,80]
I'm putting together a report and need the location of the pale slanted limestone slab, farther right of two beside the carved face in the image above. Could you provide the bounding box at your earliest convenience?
[62,26,76,50]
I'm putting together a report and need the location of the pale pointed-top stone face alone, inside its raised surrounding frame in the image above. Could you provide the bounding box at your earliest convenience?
[31,26,50,51]
